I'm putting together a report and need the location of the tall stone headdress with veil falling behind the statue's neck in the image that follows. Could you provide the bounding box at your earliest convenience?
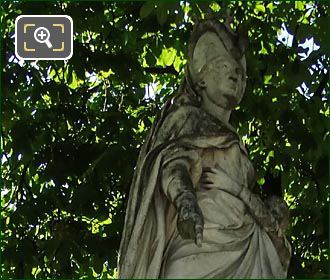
[175,19,246,105]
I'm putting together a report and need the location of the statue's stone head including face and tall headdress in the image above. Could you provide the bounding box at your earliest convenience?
[188,21,246,109]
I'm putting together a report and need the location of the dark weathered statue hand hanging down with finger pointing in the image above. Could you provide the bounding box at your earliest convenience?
[176,192,204,247]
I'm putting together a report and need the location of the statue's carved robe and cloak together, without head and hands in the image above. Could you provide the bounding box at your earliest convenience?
[119,97,287,278]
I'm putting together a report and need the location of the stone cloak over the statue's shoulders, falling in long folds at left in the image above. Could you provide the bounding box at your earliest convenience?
[118,101,247,278]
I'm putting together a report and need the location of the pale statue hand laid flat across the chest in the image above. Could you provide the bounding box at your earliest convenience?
[201,166,243,196]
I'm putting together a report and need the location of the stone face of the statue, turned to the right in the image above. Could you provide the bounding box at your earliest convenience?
[203,55,245,110]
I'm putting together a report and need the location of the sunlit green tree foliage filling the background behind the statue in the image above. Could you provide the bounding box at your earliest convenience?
[1,1,329,278]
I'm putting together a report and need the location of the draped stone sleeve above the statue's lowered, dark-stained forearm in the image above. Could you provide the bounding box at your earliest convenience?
[161,147,202,202]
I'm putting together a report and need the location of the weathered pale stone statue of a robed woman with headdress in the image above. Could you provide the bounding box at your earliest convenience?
[118,19,291,278]
